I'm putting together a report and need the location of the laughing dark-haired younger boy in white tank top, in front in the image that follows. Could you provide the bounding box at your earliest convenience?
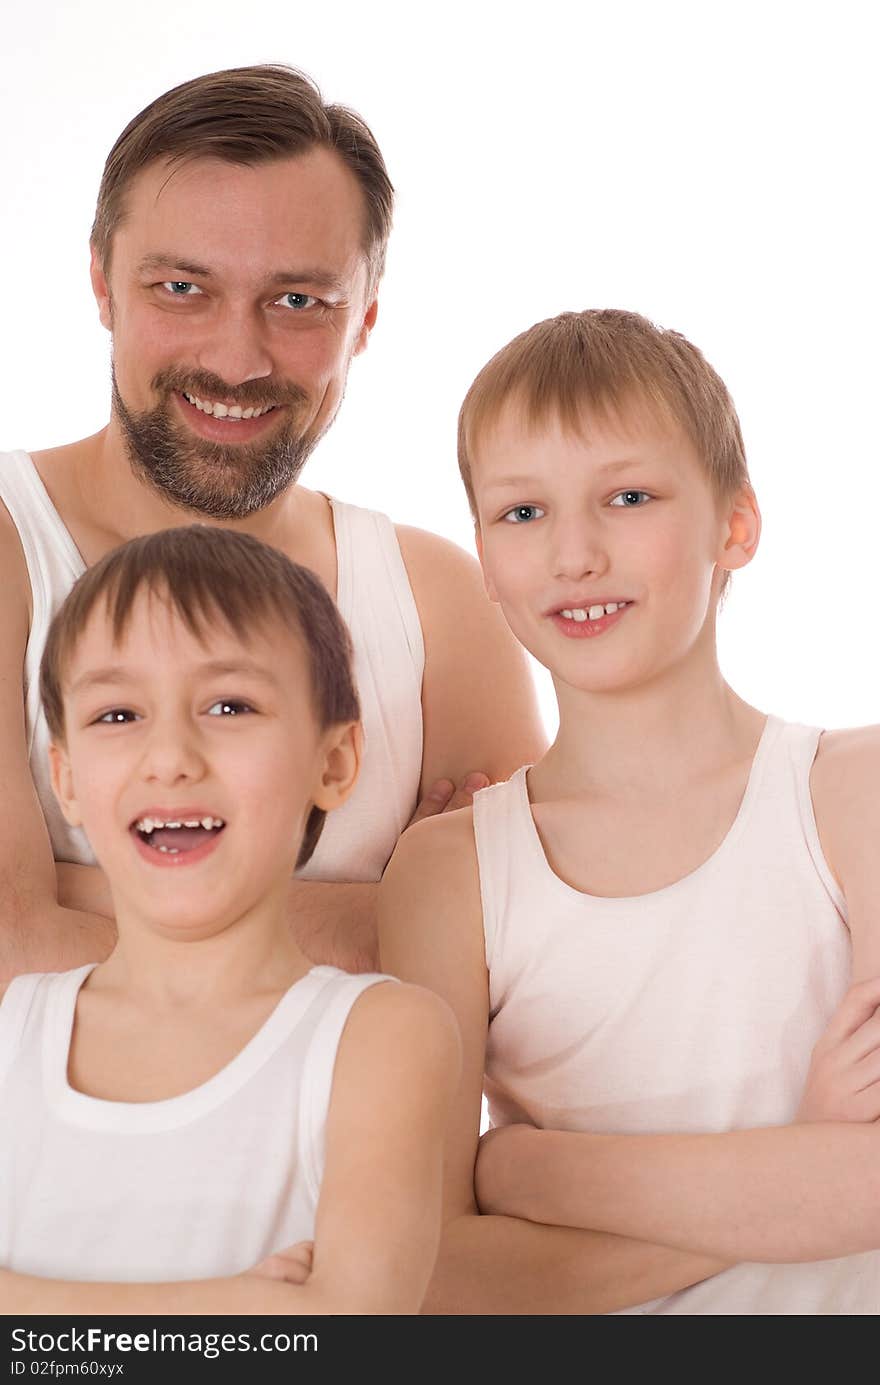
[0,526,457,1314]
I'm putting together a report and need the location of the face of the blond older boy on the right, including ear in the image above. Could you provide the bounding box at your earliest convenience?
[473,407,757,703]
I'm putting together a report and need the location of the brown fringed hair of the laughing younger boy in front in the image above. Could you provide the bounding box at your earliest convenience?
[40,525,360,870]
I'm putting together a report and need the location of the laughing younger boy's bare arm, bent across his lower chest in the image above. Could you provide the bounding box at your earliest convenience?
[0,982,459,1316]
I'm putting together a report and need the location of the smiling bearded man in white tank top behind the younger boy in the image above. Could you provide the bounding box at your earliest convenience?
[0,66,542,978]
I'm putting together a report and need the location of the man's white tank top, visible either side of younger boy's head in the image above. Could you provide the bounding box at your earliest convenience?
[0,452,424,881]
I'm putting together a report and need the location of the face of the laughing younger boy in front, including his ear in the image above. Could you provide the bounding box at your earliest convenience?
[53,593,358,939]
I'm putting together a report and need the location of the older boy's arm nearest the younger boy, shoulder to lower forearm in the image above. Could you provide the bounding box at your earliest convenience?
[380,810,725,1314]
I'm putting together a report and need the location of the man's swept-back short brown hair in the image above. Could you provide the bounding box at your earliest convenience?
[91,64,394,285]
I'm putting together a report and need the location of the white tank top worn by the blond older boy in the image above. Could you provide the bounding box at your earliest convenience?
[474,717,880,1314]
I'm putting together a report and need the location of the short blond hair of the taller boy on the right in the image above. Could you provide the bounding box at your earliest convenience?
[459,307,750,519]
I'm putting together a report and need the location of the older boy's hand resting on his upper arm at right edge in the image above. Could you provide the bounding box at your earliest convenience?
[795,976,880,1122]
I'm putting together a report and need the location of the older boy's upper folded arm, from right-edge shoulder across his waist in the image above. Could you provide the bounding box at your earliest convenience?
[477,727,880,1262]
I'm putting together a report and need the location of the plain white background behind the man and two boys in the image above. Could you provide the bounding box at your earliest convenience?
[0,0,880,729]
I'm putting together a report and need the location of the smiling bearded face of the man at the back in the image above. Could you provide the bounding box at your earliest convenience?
[93,148,376,519]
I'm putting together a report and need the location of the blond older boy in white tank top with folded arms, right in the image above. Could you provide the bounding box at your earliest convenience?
[381,312,880,1314]
